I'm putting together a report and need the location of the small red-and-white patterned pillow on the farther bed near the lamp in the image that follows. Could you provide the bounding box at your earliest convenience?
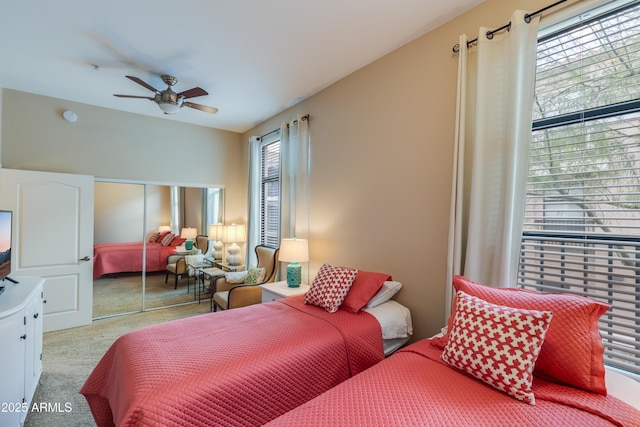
[304,264,358,313]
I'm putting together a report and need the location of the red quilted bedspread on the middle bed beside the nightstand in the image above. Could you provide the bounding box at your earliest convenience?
[80,296,384,426]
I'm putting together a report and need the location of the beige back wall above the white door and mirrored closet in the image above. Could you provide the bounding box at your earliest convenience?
[0,89,247,224]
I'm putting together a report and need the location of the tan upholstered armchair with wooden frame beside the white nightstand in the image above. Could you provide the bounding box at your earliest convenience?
[213,245,279,311]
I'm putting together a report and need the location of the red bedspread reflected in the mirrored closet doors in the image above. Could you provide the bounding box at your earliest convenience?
[93,242,176,280]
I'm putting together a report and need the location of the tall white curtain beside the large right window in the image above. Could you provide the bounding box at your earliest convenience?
[446,11,539,316]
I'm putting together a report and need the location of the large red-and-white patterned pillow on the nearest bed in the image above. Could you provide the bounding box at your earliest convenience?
[441,291,552,405]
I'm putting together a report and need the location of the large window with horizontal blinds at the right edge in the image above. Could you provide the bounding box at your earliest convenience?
[518,2,640,374]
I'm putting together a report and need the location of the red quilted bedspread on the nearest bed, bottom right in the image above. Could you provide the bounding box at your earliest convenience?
[268,340,640,427]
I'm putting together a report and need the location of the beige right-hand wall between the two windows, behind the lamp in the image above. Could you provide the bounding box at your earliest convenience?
[243,0,572,338]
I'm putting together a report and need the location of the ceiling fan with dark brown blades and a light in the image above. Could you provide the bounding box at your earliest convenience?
[113,74,218,114]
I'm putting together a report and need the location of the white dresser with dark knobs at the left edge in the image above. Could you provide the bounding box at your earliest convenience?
[0,277,44,427]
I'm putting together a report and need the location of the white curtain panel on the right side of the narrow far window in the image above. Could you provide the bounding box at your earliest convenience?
[280,115,311,283]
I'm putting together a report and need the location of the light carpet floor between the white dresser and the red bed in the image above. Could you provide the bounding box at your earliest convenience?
[25,302,210,427]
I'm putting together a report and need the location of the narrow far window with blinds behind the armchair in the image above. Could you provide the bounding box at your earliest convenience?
[260,140,280,248]
